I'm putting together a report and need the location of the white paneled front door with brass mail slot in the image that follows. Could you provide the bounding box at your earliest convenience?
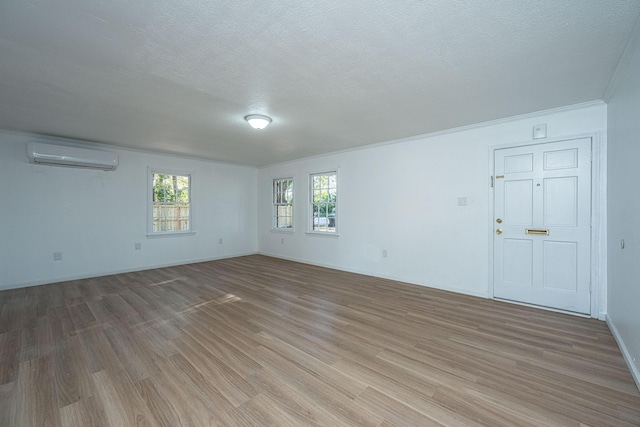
[493,138,591,314]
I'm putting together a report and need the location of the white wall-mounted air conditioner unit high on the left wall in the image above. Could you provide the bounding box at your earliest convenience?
[27,142,118,171]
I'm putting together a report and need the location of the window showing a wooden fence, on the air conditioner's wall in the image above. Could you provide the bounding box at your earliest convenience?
[150,171,192,234]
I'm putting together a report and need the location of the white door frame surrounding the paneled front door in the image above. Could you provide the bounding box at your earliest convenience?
[487,132,607,320]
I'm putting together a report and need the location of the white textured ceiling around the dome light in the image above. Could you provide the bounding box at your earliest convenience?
[0,0,640,166]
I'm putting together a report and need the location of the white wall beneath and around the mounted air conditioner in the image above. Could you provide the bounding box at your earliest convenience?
[0,132,257,289]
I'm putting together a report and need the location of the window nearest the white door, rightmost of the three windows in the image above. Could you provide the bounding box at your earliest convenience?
[309,171,338,233]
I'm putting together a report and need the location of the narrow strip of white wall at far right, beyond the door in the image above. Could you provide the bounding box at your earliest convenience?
[607,37,640,387]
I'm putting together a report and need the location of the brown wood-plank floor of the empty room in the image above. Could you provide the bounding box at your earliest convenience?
[0,255,640,427]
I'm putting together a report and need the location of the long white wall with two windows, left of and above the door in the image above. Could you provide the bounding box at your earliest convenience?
[258,103,606,297]
